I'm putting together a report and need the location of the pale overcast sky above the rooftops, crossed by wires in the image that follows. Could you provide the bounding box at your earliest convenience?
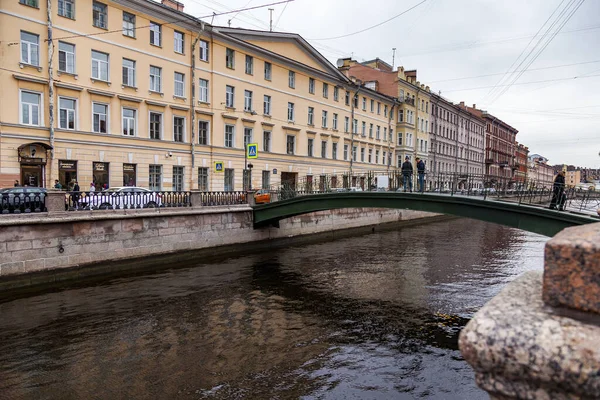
[180,0,600,168]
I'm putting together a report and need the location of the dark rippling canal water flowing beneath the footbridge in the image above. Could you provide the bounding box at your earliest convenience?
[0,219,546,399]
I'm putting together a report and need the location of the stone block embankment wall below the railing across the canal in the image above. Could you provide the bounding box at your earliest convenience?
[0,206,435,286]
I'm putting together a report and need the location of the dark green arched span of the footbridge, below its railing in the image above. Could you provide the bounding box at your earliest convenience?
[253,192,600,237]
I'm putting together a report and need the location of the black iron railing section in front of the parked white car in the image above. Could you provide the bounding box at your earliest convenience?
[65,191,192,211]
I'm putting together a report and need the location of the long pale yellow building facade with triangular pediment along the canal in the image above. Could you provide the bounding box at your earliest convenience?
[0,0,395,191]
